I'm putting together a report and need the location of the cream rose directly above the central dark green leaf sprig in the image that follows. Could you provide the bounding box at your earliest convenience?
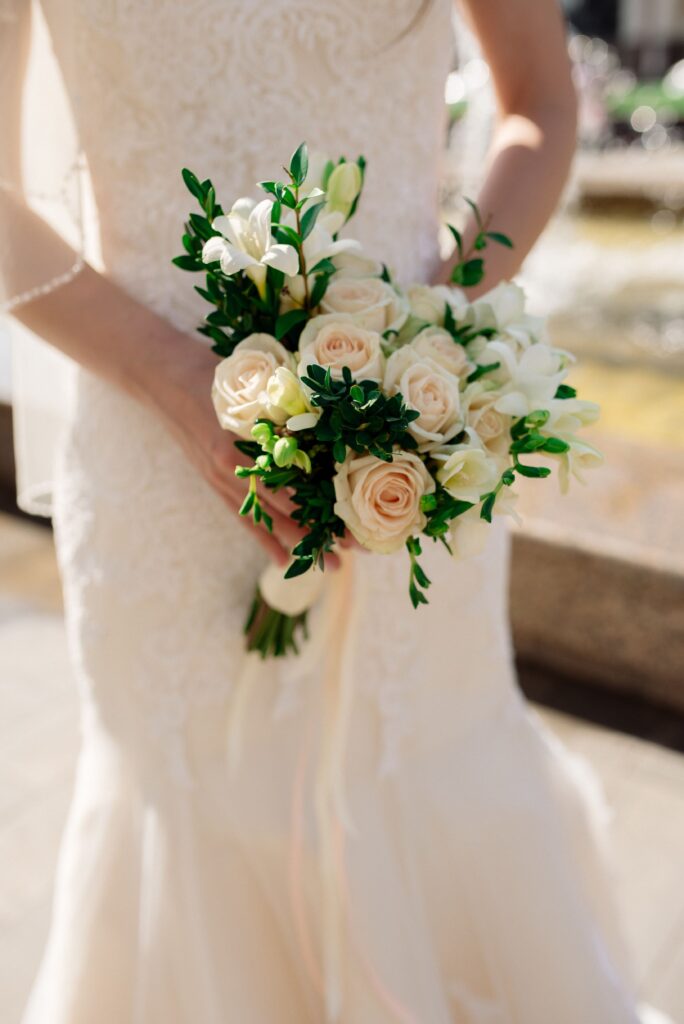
[299,313,384,381]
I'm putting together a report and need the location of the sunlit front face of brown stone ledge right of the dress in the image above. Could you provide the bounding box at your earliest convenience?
[511,527,684,712]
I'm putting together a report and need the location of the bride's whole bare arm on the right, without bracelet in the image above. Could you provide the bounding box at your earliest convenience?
[439,0,576,295]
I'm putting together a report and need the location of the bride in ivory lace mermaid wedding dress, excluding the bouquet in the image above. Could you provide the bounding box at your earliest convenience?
[0,0,663,1024]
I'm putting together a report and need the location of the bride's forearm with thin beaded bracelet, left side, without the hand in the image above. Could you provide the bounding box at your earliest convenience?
[3,192,208,411]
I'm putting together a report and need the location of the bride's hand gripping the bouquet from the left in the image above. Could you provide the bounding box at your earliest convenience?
[148,341,323,564]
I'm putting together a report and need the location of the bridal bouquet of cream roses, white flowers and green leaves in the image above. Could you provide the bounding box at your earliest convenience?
[174,144,600,656]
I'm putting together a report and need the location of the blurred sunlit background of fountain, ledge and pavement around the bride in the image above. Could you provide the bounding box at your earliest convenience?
[0,0,684,1021]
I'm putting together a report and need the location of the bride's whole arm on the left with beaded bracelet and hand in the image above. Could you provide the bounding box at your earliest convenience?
[0,14,299,561]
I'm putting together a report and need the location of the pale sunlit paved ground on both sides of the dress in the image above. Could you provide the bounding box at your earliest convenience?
[0,516,684,1024]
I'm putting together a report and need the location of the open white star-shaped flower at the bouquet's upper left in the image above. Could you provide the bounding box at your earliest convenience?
[202,199,299,297]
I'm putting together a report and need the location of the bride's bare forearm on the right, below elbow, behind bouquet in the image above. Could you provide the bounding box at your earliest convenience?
[438,102,574,297]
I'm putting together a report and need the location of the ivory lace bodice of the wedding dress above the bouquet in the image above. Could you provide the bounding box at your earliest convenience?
[44,0,452,329]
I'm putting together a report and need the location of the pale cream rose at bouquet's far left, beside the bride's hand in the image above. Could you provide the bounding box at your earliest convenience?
[211,334,294,439]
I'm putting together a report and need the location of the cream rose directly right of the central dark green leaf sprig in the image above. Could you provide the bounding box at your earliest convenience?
[383,342,463,450]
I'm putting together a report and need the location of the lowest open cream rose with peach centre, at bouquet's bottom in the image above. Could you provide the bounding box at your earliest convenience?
[334,452,435,554]
